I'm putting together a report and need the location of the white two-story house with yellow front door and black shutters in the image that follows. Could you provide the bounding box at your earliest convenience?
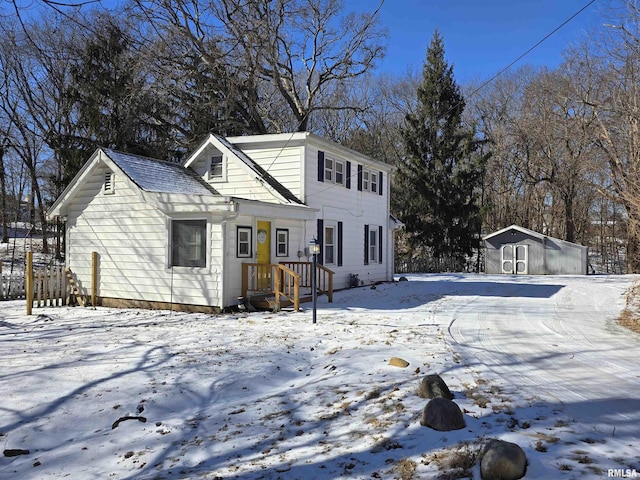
[49,132,398,309]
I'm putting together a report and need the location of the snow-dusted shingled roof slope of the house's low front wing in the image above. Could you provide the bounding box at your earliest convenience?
[104,149,218,195]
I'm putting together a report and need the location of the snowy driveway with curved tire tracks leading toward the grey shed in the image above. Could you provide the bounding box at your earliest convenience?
[449,276,640,433]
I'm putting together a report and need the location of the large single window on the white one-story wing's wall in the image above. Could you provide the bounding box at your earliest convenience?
[171,220,207,267]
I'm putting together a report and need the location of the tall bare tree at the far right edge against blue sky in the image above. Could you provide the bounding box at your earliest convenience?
[576,0,640,273]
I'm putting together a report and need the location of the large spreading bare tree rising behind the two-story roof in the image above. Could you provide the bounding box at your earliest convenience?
[130,0,384,133]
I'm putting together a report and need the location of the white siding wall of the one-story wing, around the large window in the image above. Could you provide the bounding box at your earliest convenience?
[67,166,221,306]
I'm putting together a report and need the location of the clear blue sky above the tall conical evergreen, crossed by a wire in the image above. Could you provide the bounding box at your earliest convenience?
[372,0,603,83]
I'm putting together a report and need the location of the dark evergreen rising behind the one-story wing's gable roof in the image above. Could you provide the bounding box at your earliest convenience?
[69,15,169,165]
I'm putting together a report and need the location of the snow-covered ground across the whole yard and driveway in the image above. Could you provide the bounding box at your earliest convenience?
[0,275,640,480]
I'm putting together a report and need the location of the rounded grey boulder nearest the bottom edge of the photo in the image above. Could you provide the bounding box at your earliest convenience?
[480,440,527,480]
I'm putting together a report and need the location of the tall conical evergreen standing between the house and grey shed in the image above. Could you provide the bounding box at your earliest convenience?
[394,31,485,269]
